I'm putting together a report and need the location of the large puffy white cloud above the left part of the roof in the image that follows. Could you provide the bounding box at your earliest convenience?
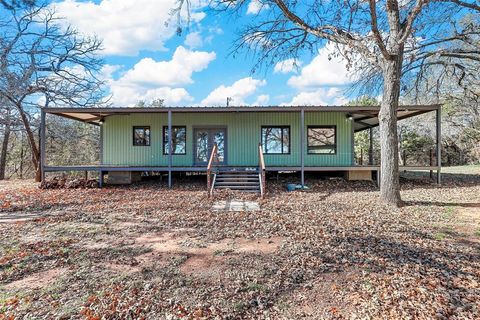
[109,46,215,106]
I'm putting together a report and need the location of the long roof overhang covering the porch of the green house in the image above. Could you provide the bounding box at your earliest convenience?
[43,104,441,132]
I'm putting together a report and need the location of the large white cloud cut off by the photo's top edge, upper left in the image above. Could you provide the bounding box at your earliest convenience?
[54,0,205,55]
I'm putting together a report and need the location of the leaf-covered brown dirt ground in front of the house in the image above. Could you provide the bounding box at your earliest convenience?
[0,166,480,319]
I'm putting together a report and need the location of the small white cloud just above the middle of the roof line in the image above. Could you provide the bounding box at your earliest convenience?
[201,77,267,106]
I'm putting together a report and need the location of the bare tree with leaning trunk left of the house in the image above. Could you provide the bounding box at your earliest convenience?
[0,1,103,181]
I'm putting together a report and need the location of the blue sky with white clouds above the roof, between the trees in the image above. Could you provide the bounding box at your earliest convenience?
[54,0,349,106]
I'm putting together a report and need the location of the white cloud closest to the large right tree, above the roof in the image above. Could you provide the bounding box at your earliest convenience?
[288,44,352,89]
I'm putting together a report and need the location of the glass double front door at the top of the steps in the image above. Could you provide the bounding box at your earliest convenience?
[193,128,227,165]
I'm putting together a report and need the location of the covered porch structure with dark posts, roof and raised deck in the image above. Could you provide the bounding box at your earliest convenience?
[40,105,441,187]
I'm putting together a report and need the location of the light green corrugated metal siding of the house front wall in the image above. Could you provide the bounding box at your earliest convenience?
[103,112,352,167]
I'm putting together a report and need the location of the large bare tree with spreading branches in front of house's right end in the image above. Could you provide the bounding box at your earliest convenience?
[174,0,480,206]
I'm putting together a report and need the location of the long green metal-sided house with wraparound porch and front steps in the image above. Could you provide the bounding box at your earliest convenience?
[41,105,440,192]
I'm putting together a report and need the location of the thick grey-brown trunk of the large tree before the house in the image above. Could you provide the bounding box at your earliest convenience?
[378,57,402,207]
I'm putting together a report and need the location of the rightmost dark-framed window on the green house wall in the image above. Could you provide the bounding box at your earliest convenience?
[307,126,337,154]
